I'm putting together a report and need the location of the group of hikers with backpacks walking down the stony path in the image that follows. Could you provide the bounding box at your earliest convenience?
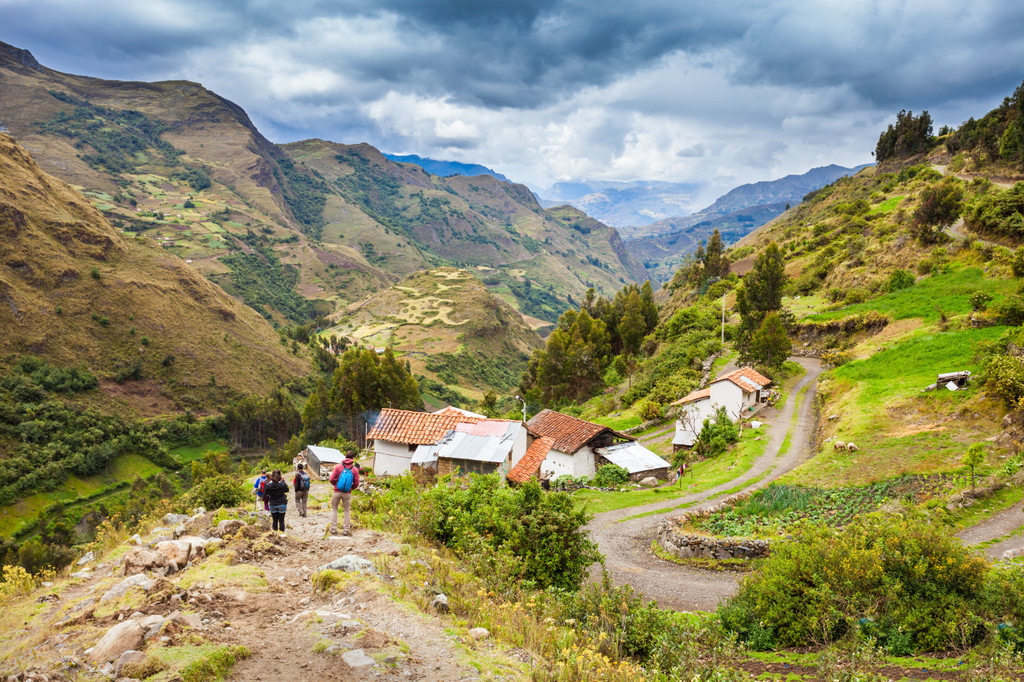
[253,457,361,536]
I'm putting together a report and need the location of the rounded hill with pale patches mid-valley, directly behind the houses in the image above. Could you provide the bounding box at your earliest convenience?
[323,267,541,400]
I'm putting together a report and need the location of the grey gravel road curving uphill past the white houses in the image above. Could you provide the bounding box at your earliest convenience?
[588,357,821,610]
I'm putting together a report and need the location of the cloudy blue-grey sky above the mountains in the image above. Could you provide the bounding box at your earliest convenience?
[0,0,1024,195]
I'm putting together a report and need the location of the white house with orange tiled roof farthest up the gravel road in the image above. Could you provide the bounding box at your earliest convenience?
[671,367,771,450]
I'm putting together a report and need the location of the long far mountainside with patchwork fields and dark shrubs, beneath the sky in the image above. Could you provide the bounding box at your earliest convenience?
[0,44,642,325]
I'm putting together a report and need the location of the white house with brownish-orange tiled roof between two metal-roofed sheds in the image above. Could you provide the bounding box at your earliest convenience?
[526,410,636,478]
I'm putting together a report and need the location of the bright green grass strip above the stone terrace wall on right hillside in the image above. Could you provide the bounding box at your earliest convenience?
[808,267,1017,323]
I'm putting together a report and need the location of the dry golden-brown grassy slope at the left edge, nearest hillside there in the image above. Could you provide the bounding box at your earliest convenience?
[0,134,308,414]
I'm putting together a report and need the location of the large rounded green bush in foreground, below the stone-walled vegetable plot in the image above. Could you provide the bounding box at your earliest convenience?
[719,509,988,651]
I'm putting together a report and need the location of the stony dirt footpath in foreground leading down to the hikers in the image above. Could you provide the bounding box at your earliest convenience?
[221,483,479,680]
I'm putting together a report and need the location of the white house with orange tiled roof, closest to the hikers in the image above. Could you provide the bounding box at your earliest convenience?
[367,408,481,476]
